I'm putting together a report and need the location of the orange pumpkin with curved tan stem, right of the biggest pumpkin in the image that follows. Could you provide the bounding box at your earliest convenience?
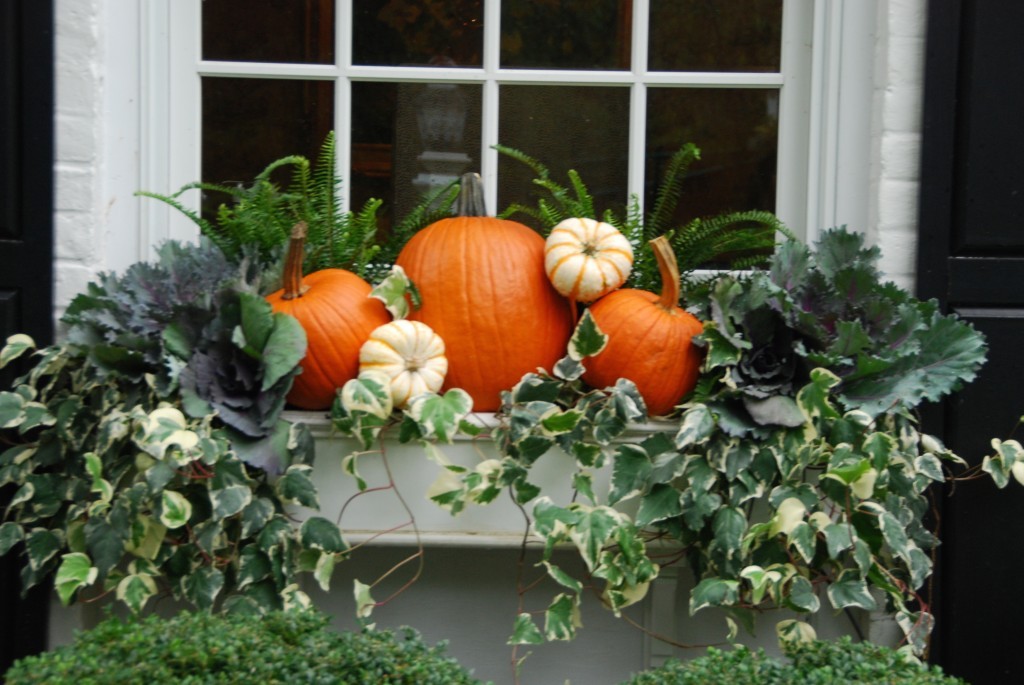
[583,237,703,416]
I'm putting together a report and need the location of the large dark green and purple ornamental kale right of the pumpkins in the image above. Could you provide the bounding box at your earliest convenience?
[694,228,986,435]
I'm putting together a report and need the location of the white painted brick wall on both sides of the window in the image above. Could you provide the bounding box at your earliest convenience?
[55,0,927,298]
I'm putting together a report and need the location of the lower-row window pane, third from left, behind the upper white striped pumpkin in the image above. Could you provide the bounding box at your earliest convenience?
[489,86,630,220]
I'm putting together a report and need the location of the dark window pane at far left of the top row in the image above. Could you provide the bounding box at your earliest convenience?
[202,0,334,65]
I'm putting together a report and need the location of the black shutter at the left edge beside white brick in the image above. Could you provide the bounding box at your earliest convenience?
[0,0,53,674]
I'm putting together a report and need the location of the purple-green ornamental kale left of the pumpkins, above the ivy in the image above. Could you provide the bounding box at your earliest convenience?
[63,241,311,472]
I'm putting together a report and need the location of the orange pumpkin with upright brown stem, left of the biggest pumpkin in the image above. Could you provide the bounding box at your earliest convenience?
[266,223,391,410]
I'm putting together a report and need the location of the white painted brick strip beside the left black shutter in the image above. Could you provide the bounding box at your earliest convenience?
[54,0,103,316]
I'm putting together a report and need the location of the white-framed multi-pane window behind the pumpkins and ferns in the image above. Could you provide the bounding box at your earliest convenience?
[115,0,873,265]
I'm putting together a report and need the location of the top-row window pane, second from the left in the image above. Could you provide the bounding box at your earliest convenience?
[352,0,483,67]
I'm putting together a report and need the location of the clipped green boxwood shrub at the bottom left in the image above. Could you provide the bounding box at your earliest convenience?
[6,610,480,685]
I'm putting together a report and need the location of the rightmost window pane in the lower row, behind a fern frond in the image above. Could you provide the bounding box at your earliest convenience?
[644,88,778,224]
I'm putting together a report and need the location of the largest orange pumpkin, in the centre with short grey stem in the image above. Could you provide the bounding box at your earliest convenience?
[396,174,572,412]
